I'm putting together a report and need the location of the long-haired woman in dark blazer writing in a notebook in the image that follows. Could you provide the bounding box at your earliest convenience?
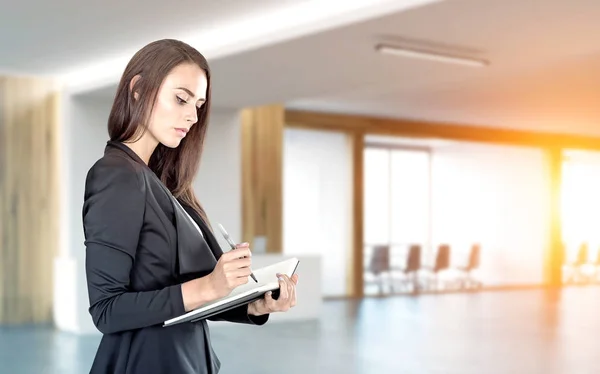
[83,40,298,374]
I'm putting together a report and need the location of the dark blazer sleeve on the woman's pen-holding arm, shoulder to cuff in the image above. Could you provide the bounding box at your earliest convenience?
[83,163,185,334]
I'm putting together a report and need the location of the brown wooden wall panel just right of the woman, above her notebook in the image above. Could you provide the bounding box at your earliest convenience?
[241,105,284,253]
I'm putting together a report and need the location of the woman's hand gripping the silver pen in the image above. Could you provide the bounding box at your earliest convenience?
[209,243,252,299]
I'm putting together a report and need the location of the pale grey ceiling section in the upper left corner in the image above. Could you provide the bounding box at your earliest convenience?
[0,0,292,75]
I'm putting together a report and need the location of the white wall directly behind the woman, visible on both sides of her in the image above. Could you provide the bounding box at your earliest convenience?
[54,96,241,333]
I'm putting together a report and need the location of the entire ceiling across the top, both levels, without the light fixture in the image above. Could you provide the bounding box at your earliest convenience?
[0,0,600,135]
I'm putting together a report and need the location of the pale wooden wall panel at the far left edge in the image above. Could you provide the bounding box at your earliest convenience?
[0,77,60,324]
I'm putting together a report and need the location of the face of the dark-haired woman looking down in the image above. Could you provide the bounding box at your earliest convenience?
[148,63,208,148]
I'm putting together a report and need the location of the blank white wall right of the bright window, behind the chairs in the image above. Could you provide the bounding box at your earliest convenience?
[432,143,550,286]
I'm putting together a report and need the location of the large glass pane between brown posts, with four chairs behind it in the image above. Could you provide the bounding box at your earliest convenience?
[364,137,549,294]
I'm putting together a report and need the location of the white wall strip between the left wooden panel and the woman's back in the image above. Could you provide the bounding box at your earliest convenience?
[54,96,111,332]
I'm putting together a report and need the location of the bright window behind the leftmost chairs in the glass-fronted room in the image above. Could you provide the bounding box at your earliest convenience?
[363,145,431,294]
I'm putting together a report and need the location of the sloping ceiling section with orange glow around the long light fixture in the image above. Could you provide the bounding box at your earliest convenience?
[215,0,600,134]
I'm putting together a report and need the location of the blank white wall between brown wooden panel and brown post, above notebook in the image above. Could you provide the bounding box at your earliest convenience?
[283,129,352,296]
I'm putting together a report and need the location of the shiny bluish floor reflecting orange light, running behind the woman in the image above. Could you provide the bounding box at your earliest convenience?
[0,287,600,374]
